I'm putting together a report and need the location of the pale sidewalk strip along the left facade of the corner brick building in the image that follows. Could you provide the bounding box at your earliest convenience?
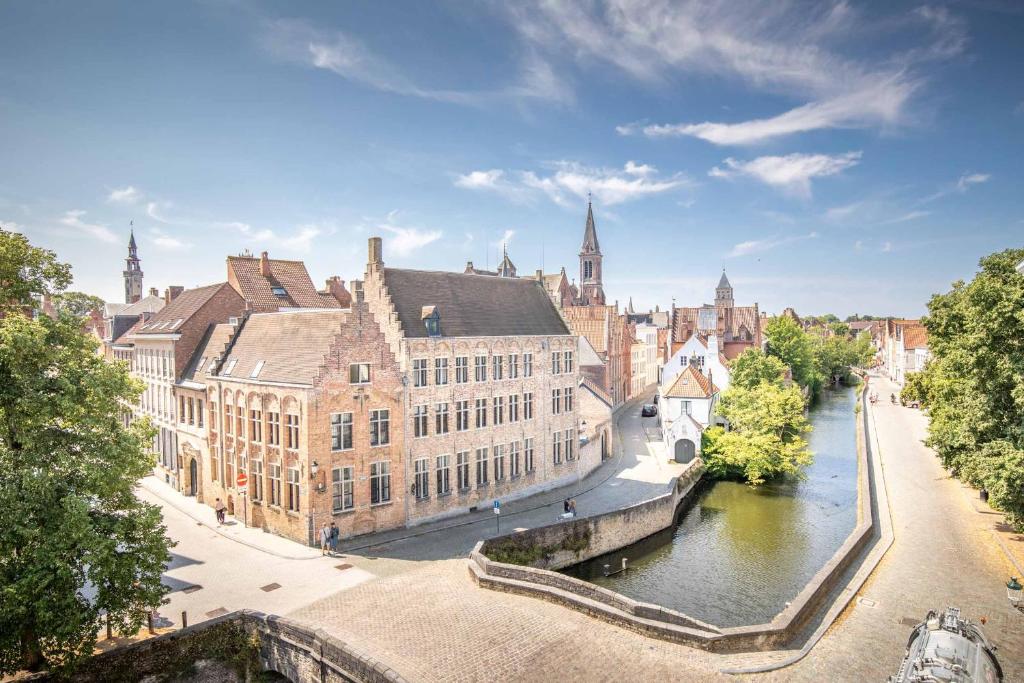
[138,475,321,560]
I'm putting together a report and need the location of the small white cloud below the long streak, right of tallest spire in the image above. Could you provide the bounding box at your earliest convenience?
[708,152,861,197]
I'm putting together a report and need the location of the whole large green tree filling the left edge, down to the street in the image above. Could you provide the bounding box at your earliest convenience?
[0,231,170,676]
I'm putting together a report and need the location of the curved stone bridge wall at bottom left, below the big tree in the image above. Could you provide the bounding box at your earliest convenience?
[30,609,404,683]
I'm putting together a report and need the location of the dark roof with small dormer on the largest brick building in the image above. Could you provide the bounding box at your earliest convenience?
[384,268,569,337]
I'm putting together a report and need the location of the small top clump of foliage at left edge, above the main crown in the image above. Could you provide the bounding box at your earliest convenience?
[0,228,71,316]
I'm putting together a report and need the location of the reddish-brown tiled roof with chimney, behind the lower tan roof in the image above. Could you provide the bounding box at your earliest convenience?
[227,256,341,311]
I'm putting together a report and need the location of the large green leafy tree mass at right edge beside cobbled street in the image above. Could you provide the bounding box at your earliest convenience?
[917,249,1024,530]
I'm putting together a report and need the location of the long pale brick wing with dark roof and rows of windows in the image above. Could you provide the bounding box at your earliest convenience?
[365,238,599,523]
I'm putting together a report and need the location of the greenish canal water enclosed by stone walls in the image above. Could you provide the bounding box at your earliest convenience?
[566,387,857,627]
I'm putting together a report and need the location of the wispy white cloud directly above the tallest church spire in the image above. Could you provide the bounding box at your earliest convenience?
[456,161,689,207]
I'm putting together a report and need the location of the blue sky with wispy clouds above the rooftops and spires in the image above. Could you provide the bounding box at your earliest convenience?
[0,0,1024,315]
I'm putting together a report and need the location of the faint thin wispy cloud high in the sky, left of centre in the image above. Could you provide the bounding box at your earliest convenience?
[263,19,573,106]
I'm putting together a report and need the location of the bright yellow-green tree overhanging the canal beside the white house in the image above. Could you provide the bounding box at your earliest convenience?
[701,382,812,485]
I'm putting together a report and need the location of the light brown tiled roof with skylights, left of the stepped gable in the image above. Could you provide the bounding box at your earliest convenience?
[219,308,349,384]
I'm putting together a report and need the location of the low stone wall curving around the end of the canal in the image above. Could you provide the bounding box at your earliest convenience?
[469,389,879,651]
